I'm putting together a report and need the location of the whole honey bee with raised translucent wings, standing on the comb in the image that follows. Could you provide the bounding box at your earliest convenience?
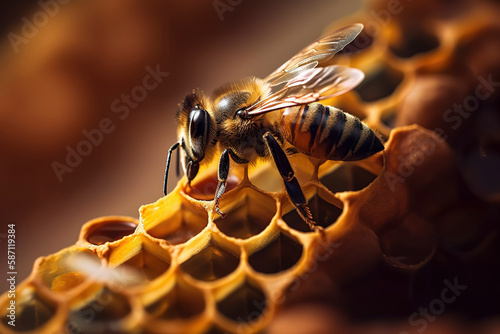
[163,24,384,229]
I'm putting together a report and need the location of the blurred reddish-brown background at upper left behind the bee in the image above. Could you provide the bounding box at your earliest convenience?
[0,0,362,291]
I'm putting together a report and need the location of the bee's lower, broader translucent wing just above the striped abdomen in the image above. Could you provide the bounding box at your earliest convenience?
[247,65,364,116]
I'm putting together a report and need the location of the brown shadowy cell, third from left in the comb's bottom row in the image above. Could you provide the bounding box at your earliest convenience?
[146,282,205,320]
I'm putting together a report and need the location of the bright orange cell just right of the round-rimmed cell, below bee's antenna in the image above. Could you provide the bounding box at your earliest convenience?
[144,200,208,245]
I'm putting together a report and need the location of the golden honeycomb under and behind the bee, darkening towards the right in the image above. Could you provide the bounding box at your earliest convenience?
[0,0,500,333]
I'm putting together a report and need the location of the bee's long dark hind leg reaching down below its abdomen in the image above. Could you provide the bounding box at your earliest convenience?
[264,132,321,230]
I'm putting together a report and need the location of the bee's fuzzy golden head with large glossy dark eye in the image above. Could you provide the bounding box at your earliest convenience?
[176,92,215,182]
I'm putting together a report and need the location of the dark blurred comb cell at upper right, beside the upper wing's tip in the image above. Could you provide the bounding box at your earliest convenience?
[389,24,439,58]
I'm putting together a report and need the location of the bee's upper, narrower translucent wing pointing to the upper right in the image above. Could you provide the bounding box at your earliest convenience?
[264,23,363,86]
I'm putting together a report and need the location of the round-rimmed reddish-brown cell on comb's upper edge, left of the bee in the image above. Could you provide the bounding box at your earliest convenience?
[80,216,138,245]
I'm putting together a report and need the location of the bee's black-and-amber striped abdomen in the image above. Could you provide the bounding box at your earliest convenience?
[281,103,384,161]
